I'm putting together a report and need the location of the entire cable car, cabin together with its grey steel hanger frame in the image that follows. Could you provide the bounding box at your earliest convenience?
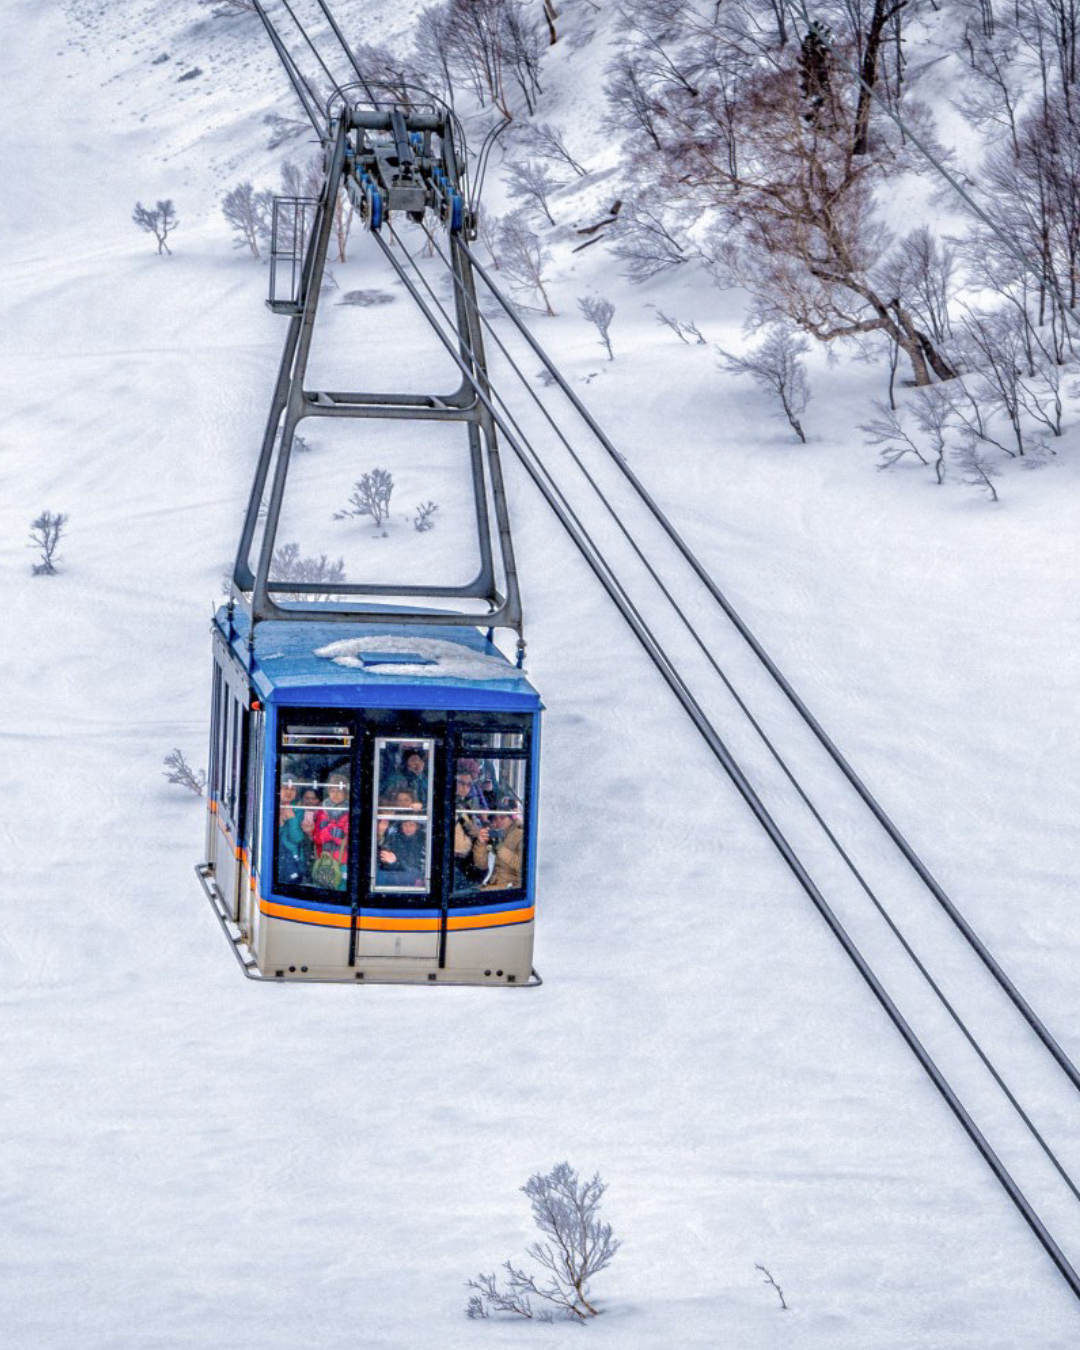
[196,92,540,987]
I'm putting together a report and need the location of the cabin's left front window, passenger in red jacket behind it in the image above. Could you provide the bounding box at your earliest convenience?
[274,717,352,903]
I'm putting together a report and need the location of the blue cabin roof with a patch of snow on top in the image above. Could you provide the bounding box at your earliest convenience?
[215,606,540,711]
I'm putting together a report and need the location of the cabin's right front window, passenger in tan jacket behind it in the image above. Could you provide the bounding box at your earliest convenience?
[454,732,528,892]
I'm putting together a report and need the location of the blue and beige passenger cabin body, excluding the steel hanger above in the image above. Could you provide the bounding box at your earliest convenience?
[205,608,540,984]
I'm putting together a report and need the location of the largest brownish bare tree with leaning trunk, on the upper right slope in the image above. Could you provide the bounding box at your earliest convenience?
[622,13,954,385]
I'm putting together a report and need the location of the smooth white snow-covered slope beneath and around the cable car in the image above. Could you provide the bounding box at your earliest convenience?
[0,0,1080,1350]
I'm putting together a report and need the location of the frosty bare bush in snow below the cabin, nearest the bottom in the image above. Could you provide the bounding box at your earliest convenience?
[466,1162,620,1322]
